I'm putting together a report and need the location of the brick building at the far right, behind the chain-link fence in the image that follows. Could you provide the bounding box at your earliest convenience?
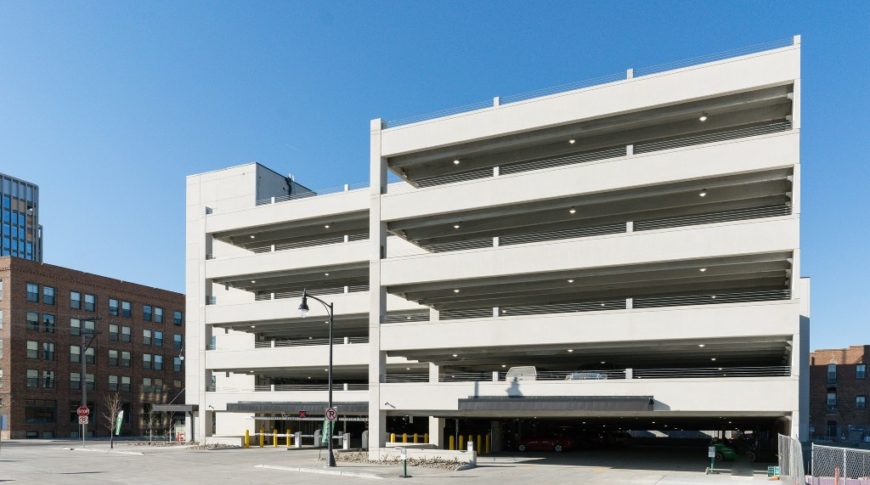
[810,345,870,444]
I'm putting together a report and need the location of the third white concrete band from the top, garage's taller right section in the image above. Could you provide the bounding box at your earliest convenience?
[381,216,799,286]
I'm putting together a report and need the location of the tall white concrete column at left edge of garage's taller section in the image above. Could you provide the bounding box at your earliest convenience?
[368,119,387,460]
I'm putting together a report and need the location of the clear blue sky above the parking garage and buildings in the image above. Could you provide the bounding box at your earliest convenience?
[0,1,870,348]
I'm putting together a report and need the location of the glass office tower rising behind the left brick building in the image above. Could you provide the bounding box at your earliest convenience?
[0,173,42,262]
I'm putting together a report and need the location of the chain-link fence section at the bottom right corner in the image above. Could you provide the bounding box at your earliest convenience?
[812,444,870,485]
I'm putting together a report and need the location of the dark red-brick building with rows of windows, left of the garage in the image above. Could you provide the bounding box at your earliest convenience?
[0,257,184,438]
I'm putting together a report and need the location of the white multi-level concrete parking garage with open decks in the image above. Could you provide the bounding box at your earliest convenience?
[186,38,809,457]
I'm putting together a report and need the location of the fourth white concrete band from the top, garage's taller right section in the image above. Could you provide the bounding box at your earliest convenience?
[381,300,799,351]
